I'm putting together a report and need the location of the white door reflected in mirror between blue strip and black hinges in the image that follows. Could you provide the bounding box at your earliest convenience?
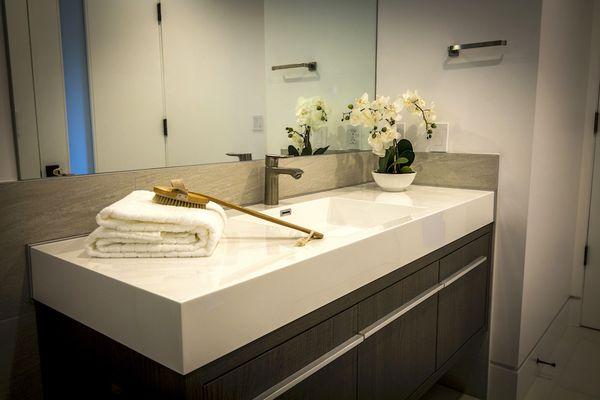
[85,0,166,172]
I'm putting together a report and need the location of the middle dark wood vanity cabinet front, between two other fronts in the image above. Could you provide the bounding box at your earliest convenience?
[358,262,438,400]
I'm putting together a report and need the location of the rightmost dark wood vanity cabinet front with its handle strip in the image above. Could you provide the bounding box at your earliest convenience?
[437,235,490,368]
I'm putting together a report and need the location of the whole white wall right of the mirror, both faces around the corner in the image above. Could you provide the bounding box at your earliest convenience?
[377,0,600,396]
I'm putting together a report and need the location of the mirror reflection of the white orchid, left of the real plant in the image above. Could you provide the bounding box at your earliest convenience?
[285,96,331,156]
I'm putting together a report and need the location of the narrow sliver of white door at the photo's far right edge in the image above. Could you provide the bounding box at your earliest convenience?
[581,118,600,329]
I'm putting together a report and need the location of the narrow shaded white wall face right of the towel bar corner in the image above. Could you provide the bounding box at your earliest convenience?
[519,0,597,365]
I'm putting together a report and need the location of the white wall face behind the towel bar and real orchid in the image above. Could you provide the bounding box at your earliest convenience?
[377,0,541,366]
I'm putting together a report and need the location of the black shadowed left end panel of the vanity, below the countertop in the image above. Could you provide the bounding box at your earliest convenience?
[36,303,185,400]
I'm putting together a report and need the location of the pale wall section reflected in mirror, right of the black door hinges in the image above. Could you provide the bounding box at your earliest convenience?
[161,0,265,166]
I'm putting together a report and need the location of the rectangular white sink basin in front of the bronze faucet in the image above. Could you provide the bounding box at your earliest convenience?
[230,197,424,237]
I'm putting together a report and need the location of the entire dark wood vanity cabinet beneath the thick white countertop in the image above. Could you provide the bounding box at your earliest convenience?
[37,225,492,400]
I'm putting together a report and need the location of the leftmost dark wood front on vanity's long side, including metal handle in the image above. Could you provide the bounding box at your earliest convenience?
[202,308,362,399]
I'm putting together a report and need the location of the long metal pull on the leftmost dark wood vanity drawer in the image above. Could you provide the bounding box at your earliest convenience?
[254,335,364,400]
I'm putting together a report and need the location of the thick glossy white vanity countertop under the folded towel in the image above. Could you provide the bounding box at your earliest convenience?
[31,184,494,374]
